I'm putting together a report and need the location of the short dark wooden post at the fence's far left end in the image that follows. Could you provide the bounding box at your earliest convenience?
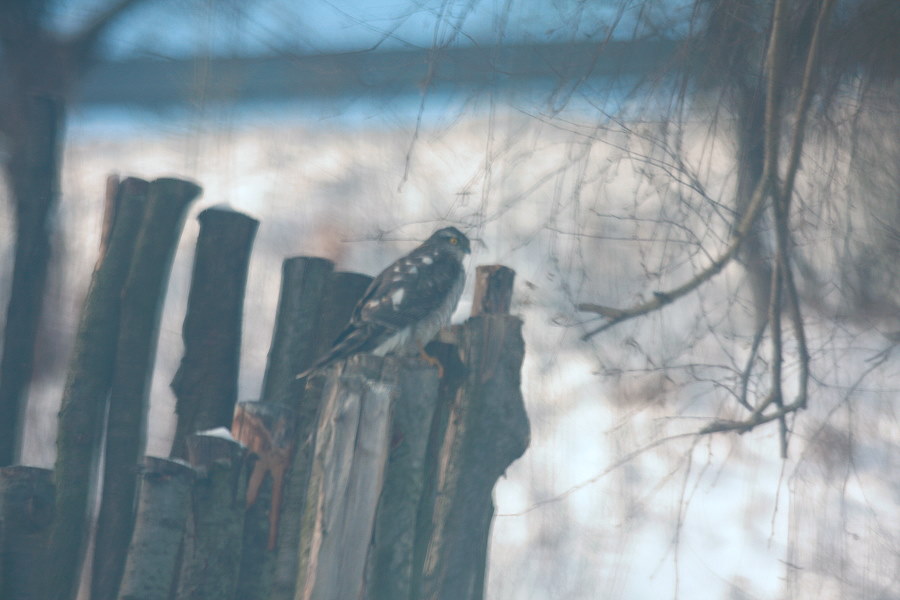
[0,466,53,600]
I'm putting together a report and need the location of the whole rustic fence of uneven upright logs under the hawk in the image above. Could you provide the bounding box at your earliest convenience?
[0,178,529,600]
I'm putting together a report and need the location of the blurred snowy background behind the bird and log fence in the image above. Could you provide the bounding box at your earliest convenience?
[0,0,900,600]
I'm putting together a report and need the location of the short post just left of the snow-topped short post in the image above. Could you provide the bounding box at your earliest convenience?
[118,456,195,600]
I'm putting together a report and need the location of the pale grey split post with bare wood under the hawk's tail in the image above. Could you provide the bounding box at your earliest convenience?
[296,355,396,600]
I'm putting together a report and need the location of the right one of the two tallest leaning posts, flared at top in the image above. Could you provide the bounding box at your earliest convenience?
[91,179,200,600]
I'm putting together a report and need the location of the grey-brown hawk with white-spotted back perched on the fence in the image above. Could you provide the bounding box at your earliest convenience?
[297,227,471,378]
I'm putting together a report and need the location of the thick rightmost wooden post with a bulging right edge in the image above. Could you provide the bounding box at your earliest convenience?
[411,270,529,600]
